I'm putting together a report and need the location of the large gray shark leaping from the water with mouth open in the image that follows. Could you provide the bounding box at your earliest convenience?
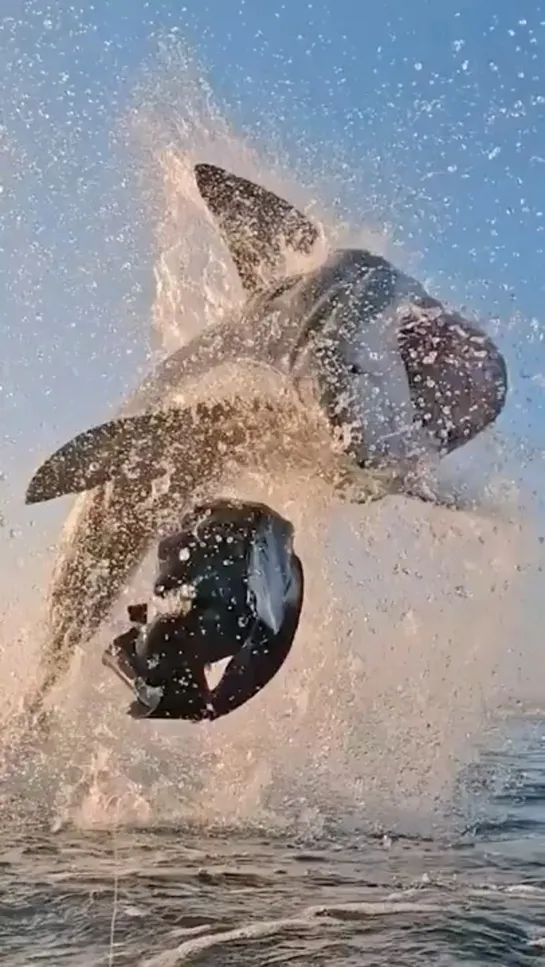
[22,165,507,714]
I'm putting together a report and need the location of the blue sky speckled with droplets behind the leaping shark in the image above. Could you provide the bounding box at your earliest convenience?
[0,0,545,544]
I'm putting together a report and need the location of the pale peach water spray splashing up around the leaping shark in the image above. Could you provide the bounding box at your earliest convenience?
[0,39,534,829]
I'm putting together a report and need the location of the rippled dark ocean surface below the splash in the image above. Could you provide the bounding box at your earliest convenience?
[0,716,545,967]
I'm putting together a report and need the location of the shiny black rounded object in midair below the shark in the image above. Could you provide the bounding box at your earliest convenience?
[103,501,303,721]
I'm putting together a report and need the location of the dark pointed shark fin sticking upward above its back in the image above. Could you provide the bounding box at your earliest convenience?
[195,164,319,292]
